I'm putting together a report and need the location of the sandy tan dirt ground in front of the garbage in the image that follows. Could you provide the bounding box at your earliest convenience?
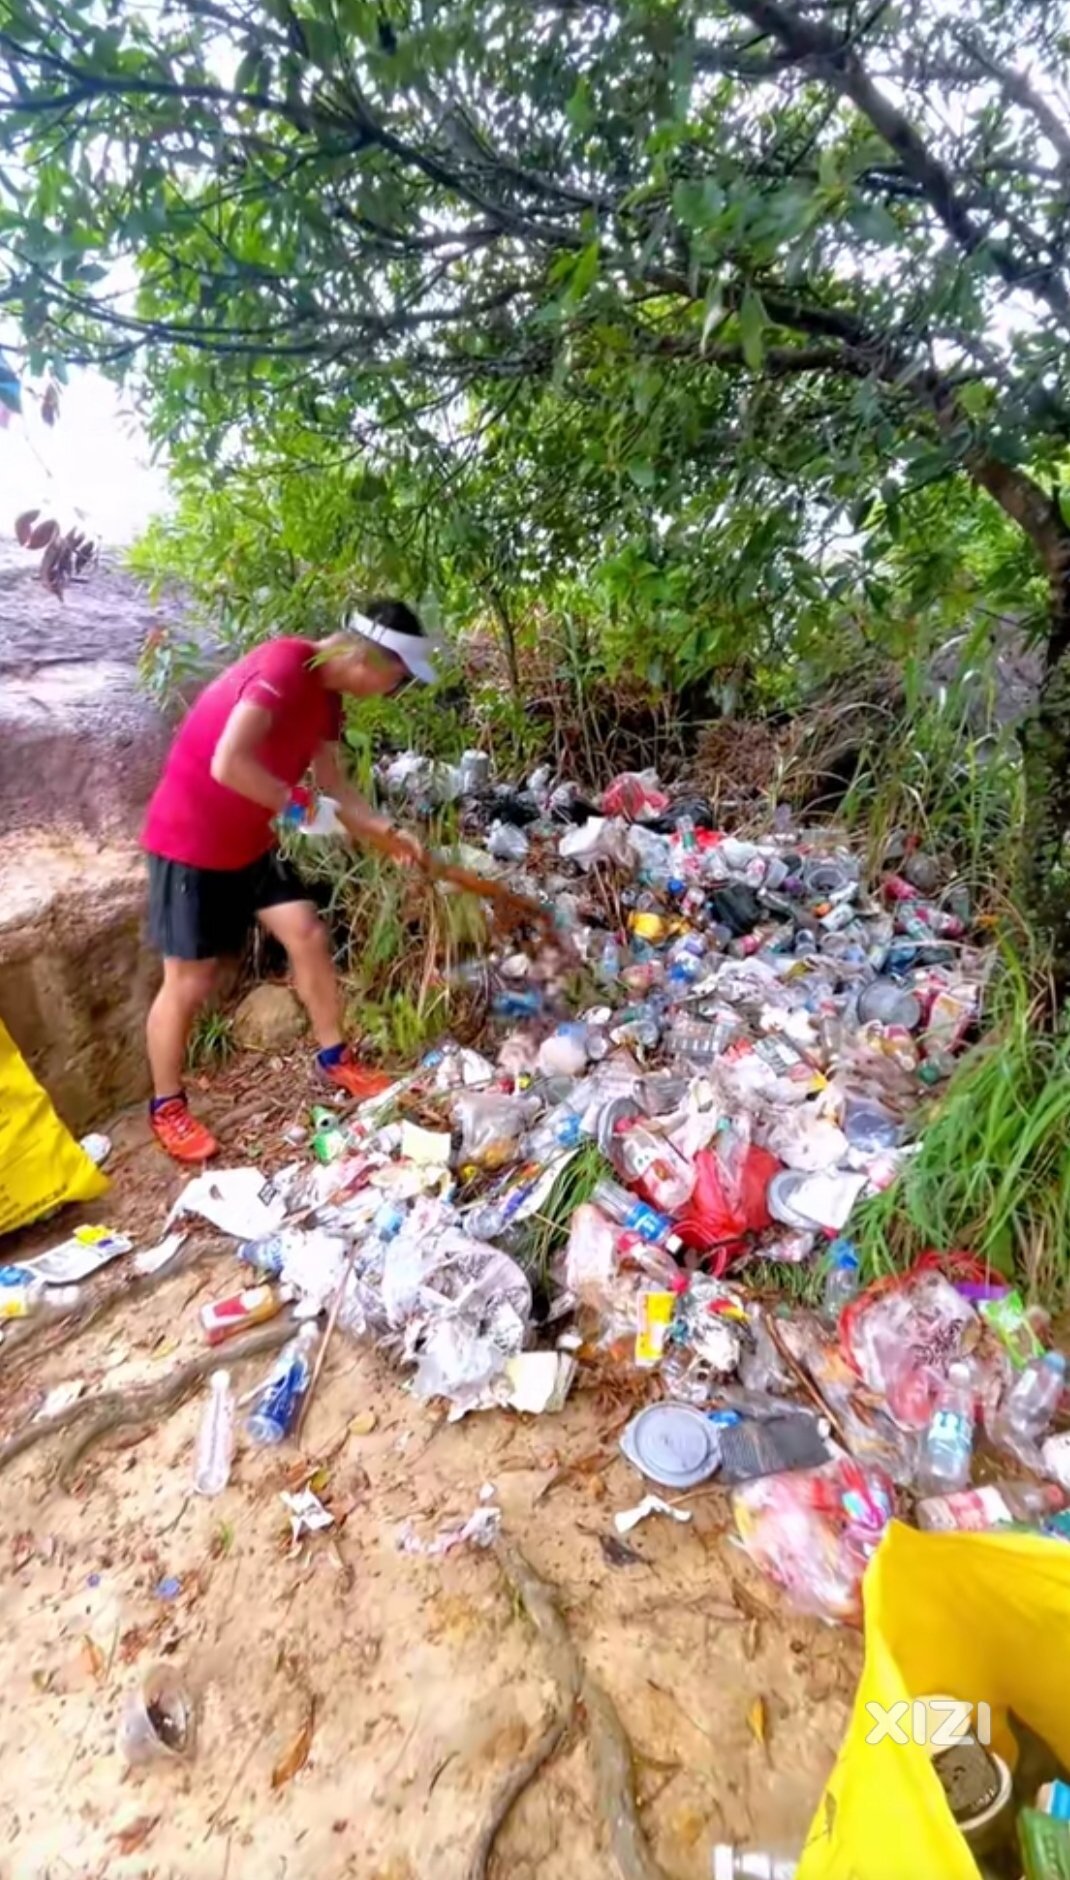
[0,1058,861,1880]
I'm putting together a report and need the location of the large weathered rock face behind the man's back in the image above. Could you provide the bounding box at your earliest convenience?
[0,541,198,1132]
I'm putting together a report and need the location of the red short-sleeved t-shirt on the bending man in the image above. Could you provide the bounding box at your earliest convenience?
[141,639,342,869]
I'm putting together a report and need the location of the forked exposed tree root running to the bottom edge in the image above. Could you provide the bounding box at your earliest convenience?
[475,1540,668,1880]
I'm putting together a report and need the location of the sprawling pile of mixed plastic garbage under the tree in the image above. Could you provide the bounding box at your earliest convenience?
[8,754,1070,1621]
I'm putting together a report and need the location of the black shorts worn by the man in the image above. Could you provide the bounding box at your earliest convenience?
[149,850,316,959]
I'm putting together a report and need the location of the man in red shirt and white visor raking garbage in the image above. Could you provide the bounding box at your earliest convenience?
[141,600,436,1162]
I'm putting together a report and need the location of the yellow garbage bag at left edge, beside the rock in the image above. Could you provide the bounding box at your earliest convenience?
[0,1025,107,1233]
